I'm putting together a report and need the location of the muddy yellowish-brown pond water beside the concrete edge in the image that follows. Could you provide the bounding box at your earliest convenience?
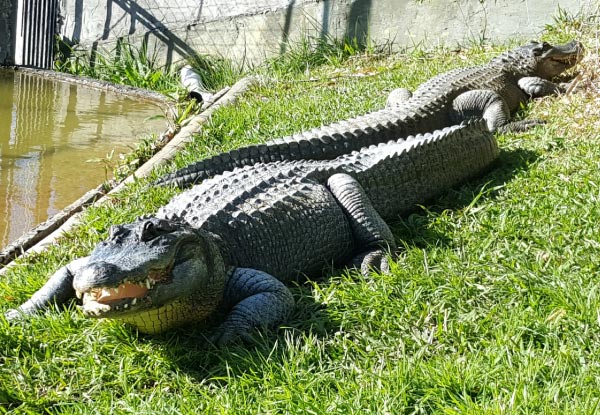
[0,69,166,250]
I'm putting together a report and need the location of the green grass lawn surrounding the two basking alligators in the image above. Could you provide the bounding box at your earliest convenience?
[0,12,600,414]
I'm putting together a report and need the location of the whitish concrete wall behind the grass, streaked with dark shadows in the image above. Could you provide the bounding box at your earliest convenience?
[56,0,597,64]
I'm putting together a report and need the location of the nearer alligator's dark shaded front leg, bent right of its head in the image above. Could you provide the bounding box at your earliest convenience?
[211,268,294,345]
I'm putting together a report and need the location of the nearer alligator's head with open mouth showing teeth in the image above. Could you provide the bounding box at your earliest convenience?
[73,218,226,332]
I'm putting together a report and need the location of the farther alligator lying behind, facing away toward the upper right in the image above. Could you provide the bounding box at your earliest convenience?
[155,41,584,187]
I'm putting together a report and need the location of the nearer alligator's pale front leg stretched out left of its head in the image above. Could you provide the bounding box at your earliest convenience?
[5,257,88,320]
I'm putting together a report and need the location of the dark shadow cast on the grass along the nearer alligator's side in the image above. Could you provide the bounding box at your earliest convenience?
[142,145,538,383]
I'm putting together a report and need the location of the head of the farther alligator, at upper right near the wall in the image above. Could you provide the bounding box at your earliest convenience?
[492,40,585,80]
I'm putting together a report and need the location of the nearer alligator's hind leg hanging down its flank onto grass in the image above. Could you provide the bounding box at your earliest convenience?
[327,173,396,275]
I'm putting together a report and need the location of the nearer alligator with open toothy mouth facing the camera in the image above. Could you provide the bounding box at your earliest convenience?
[6,121,498,344]
